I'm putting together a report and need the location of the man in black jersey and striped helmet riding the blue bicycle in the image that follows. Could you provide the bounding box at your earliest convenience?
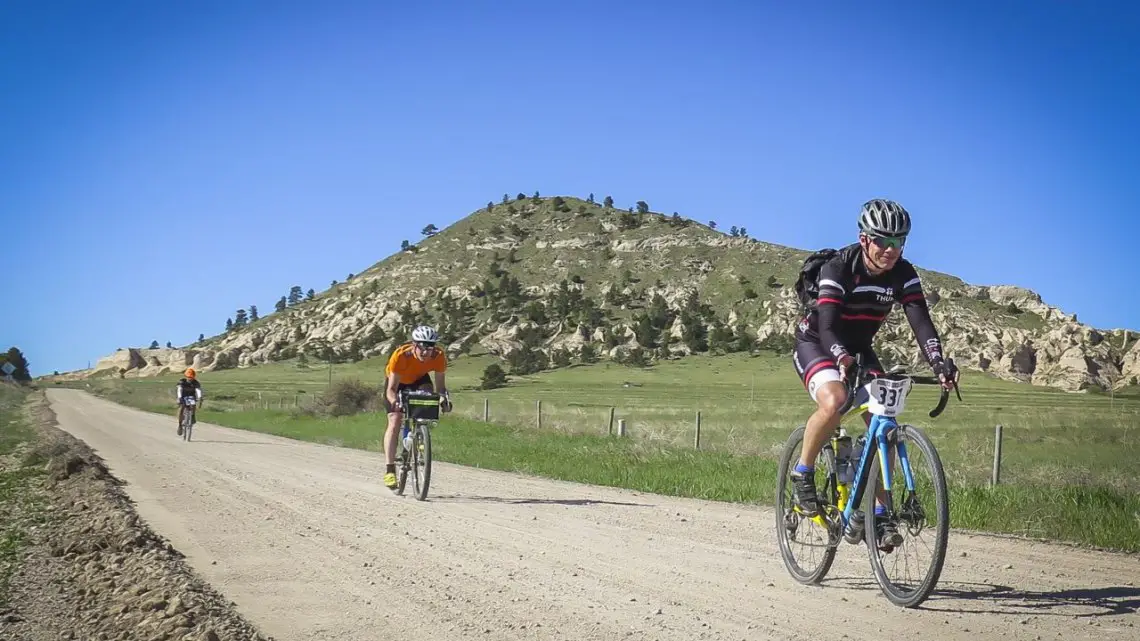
[791,198,959,546]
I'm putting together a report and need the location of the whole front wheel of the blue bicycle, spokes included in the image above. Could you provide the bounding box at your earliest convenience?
[865,424,950,608]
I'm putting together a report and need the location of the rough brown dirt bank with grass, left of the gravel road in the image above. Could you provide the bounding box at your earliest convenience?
[0,395,271,641]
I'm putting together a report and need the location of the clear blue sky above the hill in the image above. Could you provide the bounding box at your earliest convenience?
[0,0,1140,374]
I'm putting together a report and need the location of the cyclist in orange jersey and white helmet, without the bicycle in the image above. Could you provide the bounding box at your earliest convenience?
[384,325,451,488]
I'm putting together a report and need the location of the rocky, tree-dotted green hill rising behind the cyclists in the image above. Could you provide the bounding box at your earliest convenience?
[62,194,1140,390]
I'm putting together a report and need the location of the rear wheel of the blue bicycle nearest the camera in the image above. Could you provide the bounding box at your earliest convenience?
[775,425,840,584]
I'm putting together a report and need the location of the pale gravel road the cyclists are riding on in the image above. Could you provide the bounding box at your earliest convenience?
[48,389,1140,641]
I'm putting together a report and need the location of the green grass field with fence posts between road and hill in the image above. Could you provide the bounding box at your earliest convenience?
[62,355,1140,551]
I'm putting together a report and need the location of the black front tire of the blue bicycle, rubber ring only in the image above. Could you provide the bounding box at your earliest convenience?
[864,424,950,608]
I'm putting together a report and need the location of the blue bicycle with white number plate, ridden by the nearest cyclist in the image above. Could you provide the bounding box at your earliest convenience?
[775,356,962,608]
